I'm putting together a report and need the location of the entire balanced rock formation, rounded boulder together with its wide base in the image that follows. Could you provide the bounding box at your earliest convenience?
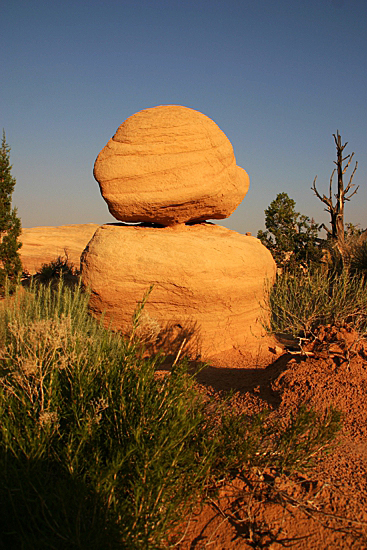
[81,105,275,358]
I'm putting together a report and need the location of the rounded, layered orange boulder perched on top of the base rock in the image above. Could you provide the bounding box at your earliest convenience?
[94,105,249,225]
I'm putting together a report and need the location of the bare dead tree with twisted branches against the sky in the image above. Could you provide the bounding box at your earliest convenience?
[311,130,359,252]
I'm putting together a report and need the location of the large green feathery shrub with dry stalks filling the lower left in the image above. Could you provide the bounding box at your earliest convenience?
[0,285,210,548]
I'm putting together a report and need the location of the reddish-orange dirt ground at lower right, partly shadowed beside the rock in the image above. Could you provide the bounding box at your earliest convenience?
[165,327,367,550]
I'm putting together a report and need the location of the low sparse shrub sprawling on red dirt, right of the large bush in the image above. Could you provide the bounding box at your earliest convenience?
[215,406,341,479]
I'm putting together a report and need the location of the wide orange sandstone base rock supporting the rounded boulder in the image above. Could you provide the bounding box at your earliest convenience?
[81,223,275,358]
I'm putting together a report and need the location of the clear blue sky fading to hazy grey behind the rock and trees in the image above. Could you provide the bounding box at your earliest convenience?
[0,0,367,234]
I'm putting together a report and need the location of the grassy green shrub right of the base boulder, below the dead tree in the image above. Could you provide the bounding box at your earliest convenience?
[268,268,367,336]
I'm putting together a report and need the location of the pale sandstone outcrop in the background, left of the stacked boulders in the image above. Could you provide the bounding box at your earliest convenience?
[19,223,99,274]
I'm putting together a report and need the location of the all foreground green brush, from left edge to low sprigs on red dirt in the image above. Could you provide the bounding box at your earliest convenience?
[0,281,339,550]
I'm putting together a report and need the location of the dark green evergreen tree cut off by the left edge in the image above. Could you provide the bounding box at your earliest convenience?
[0,130,22,294]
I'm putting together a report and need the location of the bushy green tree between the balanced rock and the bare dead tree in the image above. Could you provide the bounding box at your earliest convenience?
[257,193,321,268]
